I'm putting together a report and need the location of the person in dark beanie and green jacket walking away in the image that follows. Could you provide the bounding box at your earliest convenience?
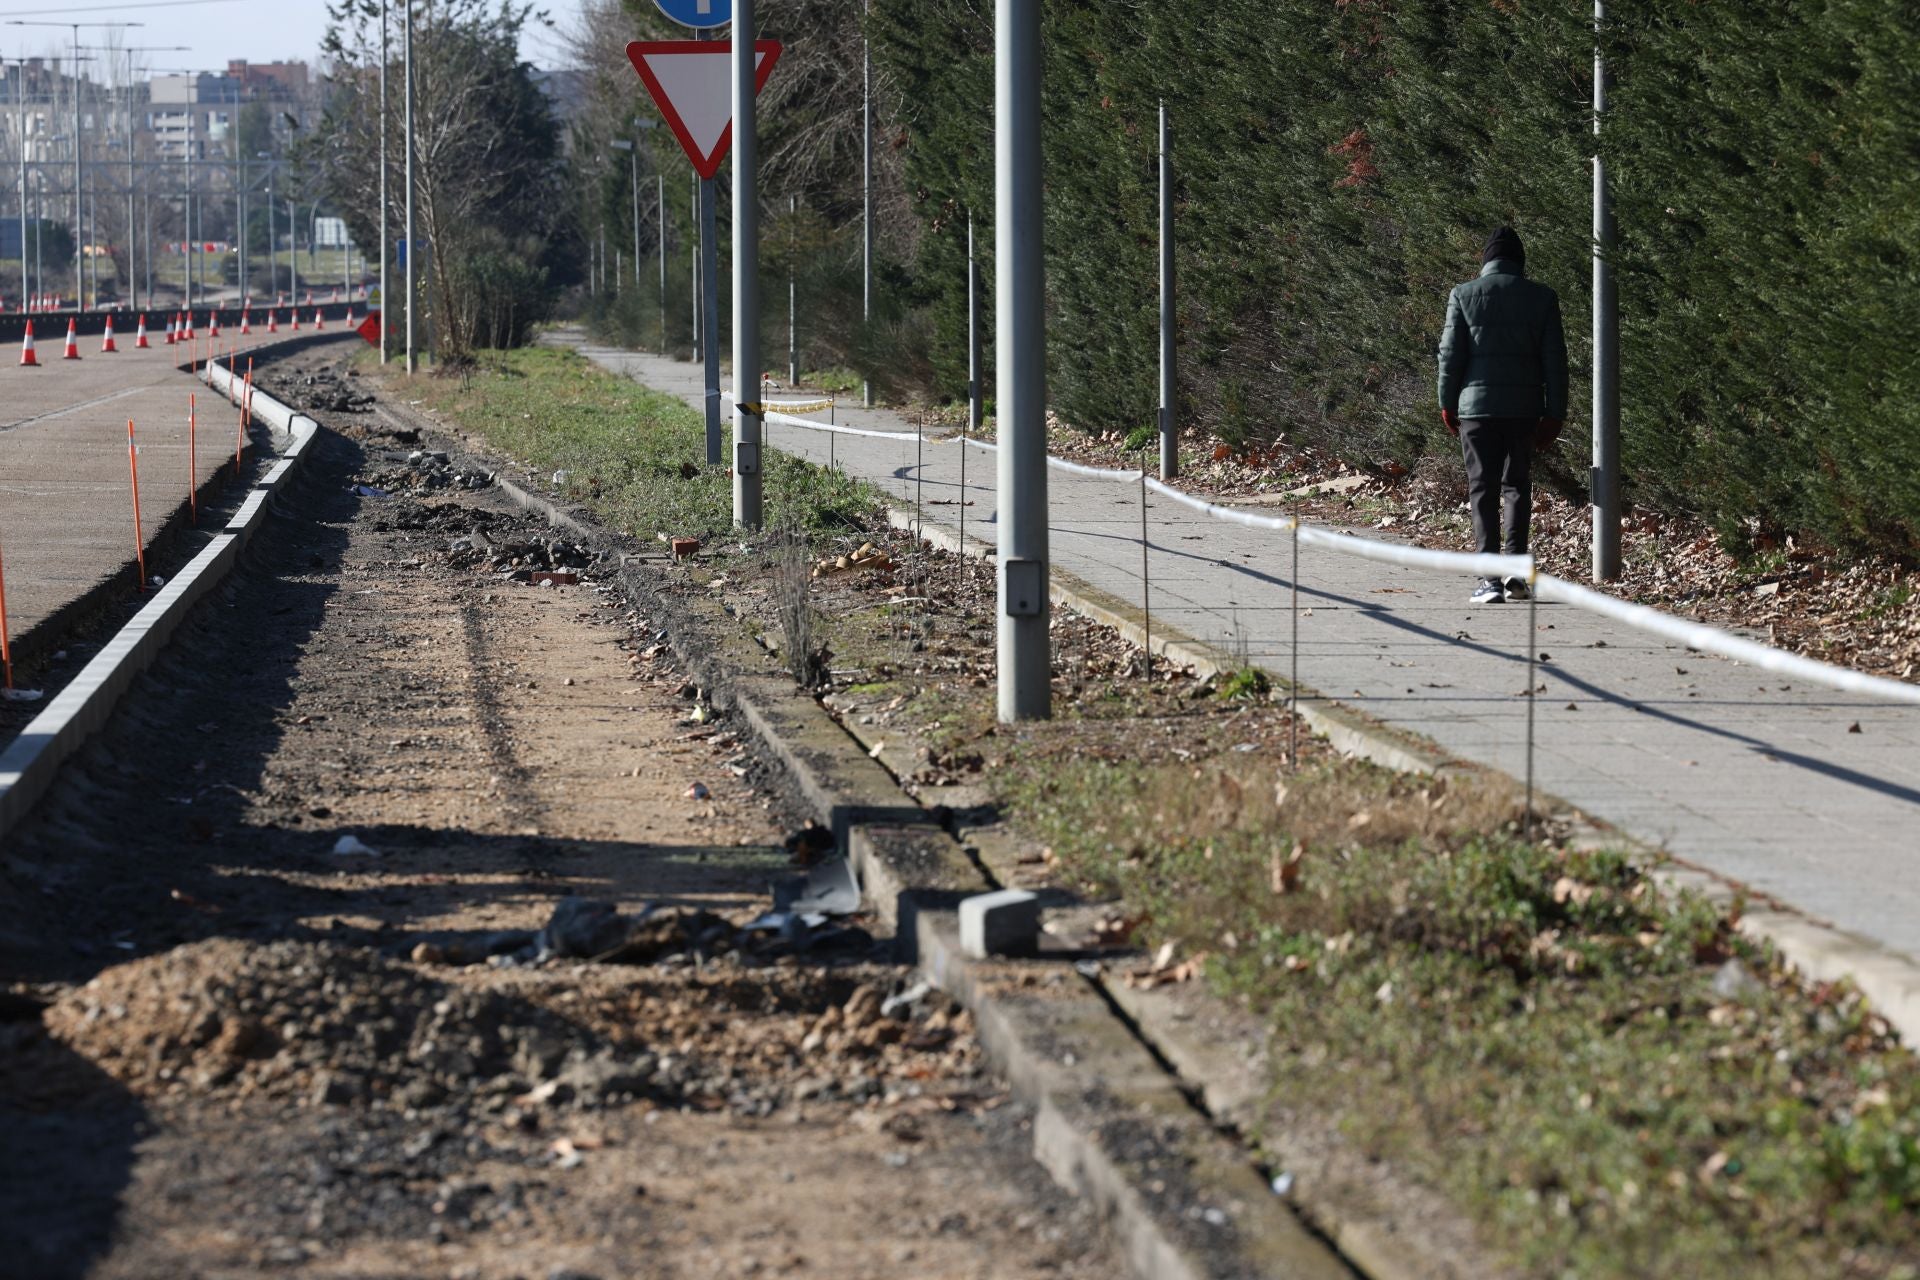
[1440,226,1567,604]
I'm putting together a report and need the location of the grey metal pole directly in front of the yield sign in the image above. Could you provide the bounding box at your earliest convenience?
[732,0,764,530]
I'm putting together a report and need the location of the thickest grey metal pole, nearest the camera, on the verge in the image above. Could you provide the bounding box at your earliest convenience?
[995,0,1052,723]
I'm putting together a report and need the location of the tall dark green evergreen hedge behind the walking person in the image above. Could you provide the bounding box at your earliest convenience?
[870,0,1920,555]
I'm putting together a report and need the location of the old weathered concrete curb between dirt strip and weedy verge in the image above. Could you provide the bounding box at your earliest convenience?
[474,476,1354,1280]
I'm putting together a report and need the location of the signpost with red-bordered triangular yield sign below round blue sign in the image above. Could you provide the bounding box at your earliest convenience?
[626,33,780,464]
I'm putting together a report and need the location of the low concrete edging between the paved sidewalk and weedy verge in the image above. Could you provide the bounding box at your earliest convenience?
[887,507,1920,1046]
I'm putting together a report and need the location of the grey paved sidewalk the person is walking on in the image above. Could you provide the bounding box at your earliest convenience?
[561,334,1920,974]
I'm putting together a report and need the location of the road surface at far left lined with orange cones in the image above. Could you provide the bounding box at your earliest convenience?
[0,313,349,637]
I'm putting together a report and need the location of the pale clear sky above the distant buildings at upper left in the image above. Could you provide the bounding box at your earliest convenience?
[0,0,580,71]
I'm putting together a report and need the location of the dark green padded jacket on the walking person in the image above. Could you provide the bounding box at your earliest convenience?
[1440,257,1567,420]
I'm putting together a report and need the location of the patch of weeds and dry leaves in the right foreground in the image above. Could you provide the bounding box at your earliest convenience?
[1008,756,1920,1280]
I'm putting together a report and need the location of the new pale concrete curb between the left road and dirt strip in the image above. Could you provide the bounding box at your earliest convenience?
[0,376,321,839]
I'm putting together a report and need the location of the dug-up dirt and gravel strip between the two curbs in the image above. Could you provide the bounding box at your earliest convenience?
[0,347,1121,1278]
